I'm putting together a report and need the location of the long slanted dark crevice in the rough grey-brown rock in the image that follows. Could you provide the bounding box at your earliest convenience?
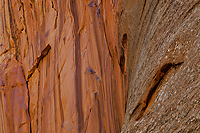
[130,62,183,121]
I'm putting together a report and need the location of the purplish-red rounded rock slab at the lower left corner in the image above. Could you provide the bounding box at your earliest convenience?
[0,58,30,133]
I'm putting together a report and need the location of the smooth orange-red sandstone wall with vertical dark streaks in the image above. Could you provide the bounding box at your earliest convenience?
[0,0,127,133]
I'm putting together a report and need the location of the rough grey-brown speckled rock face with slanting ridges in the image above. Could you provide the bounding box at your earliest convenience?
[119,0,200,133]
